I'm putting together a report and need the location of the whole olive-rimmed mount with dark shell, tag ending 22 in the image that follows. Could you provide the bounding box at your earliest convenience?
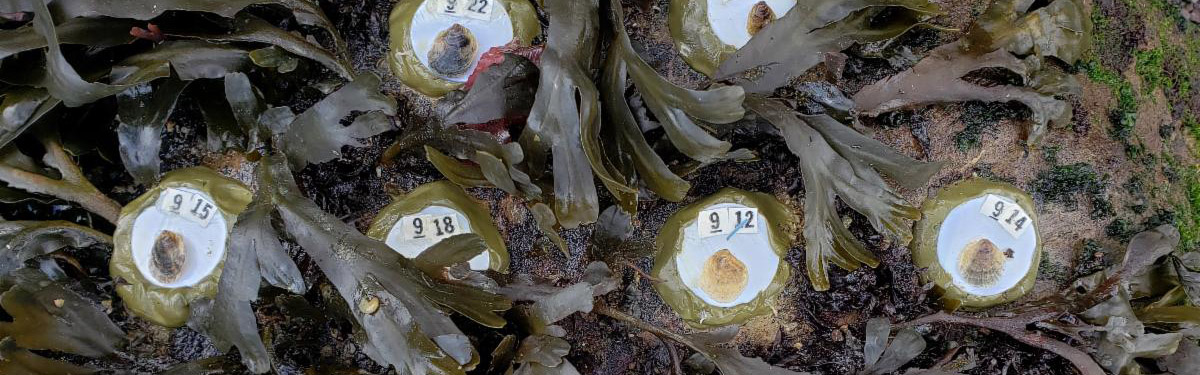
[388,0,541,96]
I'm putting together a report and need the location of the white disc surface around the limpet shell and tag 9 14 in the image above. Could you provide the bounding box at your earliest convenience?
[937,196,1038,297]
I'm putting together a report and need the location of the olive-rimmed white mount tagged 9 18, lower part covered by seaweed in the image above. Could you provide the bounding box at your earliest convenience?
[367,180,509,272]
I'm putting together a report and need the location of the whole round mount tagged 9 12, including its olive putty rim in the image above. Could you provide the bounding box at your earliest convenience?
[653,188,794,328]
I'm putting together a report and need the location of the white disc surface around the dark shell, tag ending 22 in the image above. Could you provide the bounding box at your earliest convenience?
[409,0,512,82]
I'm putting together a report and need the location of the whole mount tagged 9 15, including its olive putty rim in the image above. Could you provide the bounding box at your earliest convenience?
[108,167,252,327]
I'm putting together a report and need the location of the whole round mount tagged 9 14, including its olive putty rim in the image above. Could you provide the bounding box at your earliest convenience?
[911,179,1042,309]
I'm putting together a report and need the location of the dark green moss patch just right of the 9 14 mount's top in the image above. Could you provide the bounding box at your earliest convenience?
[1031,162,1106,207]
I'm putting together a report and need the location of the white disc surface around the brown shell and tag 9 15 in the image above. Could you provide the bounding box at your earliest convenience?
[130,188,229,287]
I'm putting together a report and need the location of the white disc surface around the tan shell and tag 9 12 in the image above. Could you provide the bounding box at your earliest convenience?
[674,203,780,308]
